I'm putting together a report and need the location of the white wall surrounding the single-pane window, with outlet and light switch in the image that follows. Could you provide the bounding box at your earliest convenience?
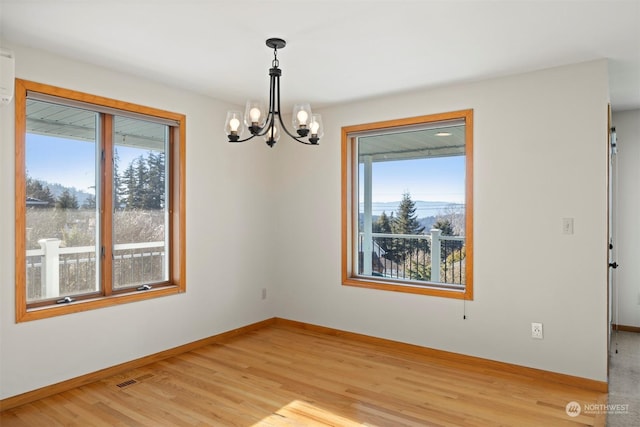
[274,61,608,381]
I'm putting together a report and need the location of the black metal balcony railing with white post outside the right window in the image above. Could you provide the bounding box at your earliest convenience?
[358,230,466,285]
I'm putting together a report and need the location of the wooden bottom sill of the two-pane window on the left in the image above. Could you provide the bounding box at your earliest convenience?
[16,285,182,323]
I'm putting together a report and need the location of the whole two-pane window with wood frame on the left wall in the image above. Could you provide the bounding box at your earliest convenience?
[15,80,186,322]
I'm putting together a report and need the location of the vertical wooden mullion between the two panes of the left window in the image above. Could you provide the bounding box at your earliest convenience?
[100,114,114,296]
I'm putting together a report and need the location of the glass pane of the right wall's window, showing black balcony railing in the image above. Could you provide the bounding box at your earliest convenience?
[353,121,466,288]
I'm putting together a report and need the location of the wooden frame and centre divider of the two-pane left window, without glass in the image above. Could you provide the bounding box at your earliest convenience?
[15,79,186,322]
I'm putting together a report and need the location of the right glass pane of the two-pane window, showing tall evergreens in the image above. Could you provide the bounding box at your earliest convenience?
[113,117,169,289]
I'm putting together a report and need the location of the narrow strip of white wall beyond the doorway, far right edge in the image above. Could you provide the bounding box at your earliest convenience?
[612,110,640,327]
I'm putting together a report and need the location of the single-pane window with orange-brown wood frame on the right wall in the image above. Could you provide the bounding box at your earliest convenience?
[342,110,473,299]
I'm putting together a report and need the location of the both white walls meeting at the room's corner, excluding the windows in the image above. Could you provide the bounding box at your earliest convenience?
[0,46,608,398]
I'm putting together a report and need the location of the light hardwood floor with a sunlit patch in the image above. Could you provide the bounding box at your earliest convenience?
[0,324,607,427]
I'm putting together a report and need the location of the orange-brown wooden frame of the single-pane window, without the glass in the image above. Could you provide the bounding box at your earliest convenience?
[341,109,473,300]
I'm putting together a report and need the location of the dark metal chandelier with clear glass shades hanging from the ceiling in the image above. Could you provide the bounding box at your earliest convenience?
[224,38,323,147]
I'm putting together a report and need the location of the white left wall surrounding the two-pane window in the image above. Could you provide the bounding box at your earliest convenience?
[0,43,275,398]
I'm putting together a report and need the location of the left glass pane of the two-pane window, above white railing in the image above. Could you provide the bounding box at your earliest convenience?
[25,100,99,303]
